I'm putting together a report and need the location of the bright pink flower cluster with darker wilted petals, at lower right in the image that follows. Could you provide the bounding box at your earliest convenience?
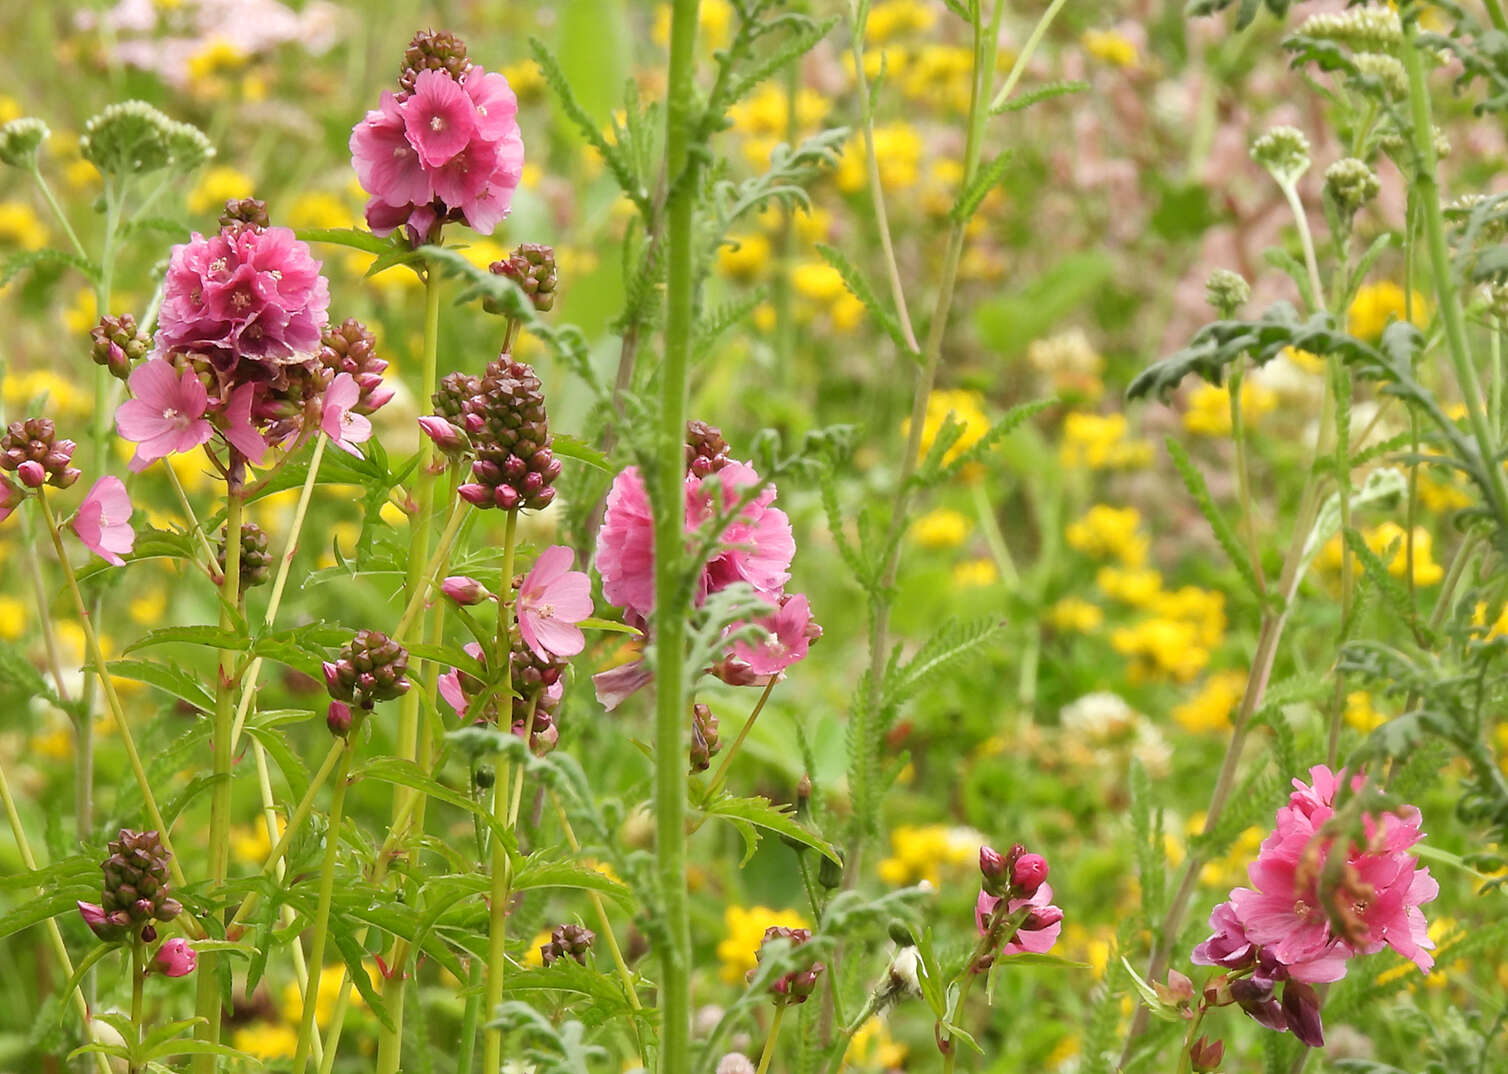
[1193,765,1440,1047]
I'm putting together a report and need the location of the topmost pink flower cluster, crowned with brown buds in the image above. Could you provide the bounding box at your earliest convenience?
[350,32,523,246]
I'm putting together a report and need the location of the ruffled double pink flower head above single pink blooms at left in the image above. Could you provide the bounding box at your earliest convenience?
[157,228,330,373]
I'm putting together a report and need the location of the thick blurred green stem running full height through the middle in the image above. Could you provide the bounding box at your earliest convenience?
[657,0,700,1074]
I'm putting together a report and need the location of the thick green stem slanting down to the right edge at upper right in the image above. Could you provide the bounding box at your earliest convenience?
[1402,30,1508,520]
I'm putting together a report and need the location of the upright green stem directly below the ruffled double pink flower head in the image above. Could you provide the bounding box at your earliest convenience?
[195,482,244,1074]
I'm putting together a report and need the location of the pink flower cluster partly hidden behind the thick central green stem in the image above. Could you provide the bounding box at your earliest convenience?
[594,422,822,709]
